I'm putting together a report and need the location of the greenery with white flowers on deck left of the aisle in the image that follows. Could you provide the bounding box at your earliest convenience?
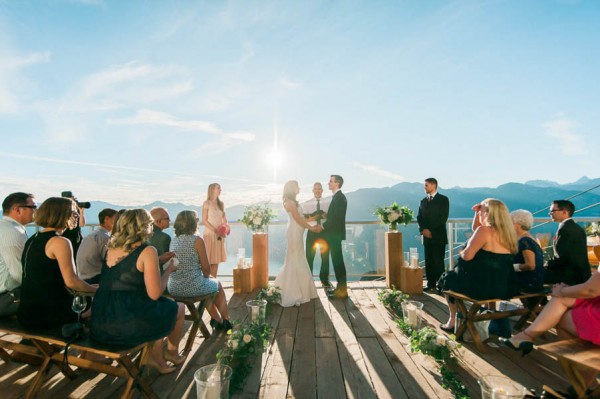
[217,322,272,393]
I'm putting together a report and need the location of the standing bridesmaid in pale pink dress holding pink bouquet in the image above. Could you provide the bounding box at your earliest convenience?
[202,183,229,277]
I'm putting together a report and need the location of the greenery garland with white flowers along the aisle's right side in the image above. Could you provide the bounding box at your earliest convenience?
[378,287,470,399]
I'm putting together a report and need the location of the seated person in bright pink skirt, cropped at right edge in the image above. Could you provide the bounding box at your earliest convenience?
[500,272,600,355]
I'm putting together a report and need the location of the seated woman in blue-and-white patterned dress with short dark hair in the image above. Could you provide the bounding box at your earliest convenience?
[168,211,232,331]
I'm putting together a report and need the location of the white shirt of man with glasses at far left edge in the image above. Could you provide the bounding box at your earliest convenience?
[0,216,27,293]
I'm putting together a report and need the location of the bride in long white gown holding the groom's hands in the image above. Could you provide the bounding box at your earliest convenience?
[274,180,320,307]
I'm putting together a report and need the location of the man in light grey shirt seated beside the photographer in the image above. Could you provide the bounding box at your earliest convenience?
[77,208,117,284]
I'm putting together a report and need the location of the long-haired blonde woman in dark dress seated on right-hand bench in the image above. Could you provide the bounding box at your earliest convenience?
[438,198,519,331]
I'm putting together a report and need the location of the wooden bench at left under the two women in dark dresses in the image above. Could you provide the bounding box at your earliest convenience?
[0,317,158,399]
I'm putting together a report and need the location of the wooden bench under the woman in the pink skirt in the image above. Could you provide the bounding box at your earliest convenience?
[537,338,600,398]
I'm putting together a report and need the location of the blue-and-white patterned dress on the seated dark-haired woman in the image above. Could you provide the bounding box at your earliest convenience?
[167,234,219,297]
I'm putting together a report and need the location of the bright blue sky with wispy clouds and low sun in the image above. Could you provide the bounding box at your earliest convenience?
[0,0,600,206]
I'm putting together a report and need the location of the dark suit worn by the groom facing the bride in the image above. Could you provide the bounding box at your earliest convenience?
[323,190,348,287]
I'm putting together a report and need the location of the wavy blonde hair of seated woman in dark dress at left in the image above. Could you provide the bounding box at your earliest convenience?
[108,209,154,252]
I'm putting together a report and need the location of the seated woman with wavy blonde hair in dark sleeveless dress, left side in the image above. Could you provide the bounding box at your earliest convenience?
[90,209,185,374]
